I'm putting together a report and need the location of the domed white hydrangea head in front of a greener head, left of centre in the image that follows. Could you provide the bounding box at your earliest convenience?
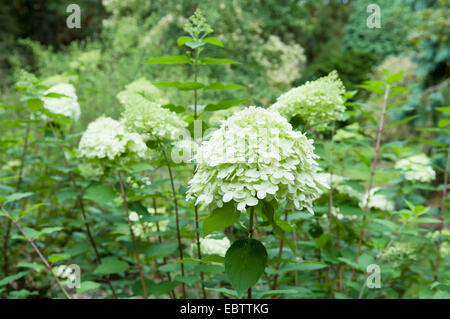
[78,117,154,163]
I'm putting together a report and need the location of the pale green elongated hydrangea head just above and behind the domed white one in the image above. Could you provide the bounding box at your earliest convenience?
[117,79,187,140]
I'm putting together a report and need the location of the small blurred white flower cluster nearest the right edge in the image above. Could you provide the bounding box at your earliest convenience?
[395,154,436,183]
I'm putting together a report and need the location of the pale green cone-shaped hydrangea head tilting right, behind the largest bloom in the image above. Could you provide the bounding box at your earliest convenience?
[270,71,345,126]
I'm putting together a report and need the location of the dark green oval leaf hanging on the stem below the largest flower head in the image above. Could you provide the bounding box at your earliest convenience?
[225,238,267,295]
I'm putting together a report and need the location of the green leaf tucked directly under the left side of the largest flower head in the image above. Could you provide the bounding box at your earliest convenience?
[202,203,240,236]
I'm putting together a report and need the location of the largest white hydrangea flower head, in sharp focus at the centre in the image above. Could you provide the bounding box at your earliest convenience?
[187,106,328,213]
